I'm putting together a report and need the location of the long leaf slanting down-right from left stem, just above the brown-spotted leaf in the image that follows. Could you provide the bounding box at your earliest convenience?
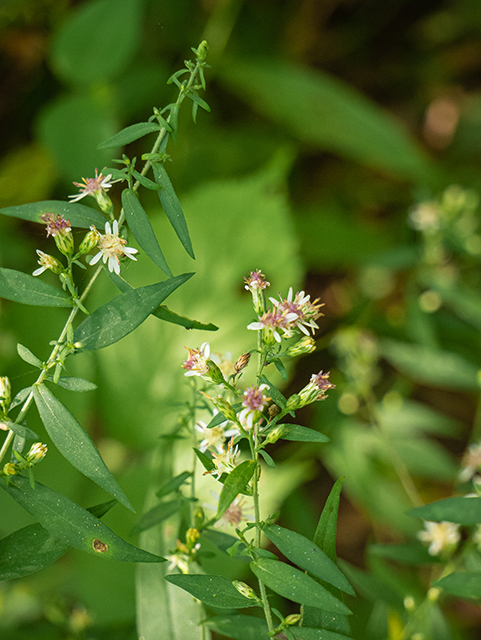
[33,384,135,511]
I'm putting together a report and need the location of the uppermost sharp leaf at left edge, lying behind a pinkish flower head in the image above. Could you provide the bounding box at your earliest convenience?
[0,200,105,229]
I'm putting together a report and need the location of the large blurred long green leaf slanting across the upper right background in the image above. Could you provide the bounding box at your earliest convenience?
[218,57,429,179]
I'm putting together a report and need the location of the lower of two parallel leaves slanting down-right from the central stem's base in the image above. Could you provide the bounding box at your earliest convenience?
[250,558,351,614]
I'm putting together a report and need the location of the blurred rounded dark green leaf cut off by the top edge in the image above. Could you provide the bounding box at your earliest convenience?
[51,0,143,85]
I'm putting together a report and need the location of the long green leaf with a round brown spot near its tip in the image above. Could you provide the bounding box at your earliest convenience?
[0,475,165,562]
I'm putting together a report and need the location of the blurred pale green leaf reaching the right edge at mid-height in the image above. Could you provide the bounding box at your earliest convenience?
[380,340,479,391]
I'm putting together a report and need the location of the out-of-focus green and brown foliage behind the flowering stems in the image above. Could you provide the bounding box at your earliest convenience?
[0,0,481,640]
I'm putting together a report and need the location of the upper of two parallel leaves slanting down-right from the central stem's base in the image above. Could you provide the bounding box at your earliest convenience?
[263,524,355,595]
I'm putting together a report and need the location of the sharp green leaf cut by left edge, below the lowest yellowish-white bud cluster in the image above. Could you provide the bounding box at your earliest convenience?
[0,268,72,307]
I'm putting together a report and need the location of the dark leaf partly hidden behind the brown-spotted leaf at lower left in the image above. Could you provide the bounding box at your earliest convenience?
[0,500,117,580]
